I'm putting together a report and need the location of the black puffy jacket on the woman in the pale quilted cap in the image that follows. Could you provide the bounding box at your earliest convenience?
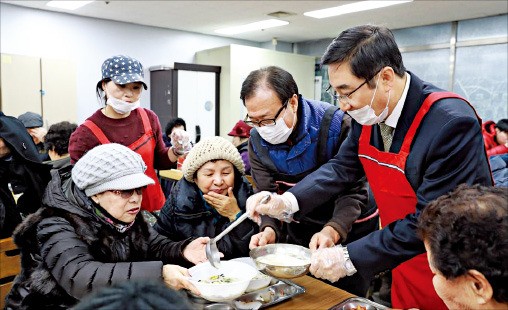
[6,167,192,309]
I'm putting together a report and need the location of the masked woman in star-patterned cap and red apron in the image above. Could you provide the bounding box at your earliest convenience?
[69,55,191,212]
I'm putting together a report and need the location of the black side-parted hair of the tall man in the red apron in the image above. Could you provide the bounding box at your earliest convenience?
[321,25,406,87]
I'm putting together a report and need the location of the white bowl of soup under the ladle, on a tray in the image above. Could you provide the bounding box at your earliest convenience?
[189,261,258,302]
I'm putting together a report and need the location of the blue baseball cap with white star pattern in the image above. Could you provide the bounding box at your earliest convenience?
[99,55,148,89]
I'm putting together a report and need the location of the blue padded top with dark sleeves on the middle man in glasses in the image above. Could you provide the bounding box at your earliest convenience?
[249,96,376,247]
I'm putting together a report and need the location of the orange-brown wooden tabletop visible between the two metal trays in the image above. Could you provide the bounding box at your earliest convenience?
[268,276,355,310]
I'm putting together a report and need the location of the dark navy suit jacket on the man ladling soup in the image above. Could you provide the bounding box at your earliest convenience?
[290,73,492,278]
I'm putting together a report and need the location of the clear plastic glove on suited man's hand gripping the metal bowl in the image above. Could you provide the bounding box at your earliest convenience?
[309,245,347,282]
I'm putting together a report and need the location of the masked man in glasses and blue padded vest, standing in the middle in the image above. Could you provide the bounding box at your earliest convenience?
[240,66,377,296]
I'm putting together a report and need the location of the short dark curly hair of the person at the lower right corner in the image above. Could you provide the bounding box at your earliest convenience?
[418,184,508,302]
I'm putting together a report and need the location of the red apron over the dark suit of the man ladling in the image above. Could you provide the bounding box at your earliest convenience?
[358,92,474,309]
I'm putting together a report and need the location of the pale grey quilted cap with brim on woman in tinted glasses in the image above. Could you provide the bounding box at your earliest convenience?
[72,143,155,197]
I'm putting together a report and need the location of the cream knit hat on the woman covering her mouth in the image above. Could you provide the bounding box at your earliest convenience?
[182,137,245,182]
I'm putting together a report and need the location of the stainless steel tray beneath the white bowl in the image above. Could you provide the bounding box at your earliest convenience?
[189,279,305,310]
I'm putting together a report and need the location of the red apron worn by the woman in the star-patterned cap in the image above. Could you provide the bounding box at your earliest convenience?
[83,108,166,212]
